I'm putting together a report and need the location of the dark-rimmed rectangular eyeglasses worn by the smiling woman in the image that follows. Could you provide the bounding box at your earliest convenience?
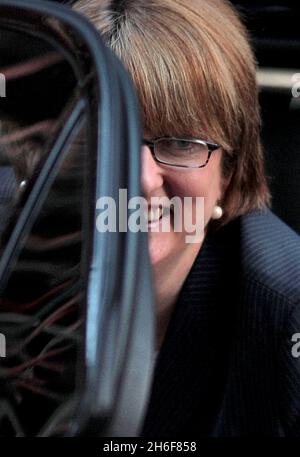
[143,137,221,168]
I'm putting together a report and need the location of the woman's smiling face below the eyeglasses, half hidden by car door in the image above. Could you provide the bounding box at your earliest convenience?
[141,146,222,268]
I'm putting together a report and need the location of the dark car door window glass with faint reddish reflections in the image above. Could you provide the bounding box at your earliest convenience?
[0,27,87,436]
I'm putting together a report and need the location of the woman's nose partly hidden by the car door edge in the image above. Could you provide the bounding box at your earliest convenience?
[141,146,164,197]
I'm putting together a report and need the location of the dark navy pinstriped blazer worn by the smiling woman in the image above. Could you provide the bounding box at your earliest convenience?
[142,210,300,438]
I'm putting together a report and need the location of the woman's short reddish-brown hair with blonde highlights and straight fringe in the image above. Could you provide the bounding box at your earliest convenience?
[75,0,270,225]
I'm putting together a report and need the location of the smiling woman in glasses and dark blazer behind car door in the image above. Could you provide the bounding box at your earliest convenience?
[75,0,300,437]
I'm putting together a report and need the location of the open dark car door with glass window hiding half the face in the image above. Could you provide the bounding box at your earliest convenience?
[0,0,154,436]
